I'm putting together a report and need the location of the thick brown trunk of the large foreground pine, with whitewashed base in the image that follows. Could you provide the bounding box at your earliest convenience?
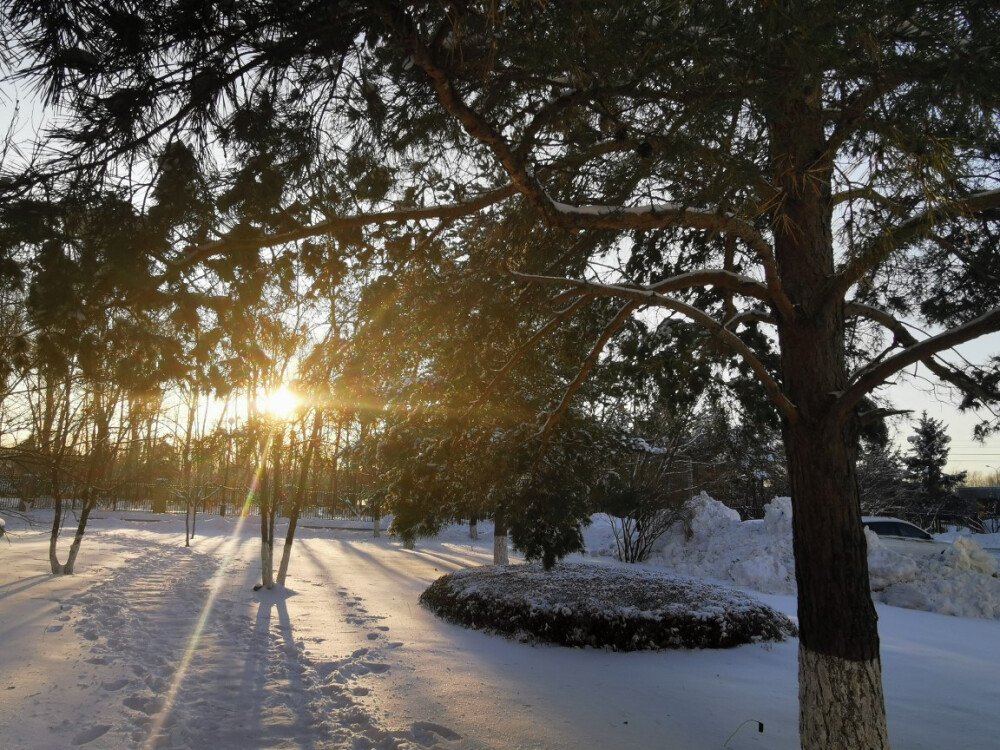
[771,97,889,750]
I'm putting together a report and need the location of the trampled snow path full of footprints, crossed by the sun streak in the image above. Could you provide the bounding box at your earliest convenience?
[19,537,461,750]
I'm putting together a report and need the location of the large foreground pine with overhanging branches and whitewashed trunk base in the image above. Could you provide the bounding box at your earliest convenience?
[2,0,1000,748]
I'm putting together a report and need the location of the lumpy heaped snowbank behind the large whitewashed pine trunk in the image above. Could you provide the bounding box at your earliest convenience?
[588,494,1000,619]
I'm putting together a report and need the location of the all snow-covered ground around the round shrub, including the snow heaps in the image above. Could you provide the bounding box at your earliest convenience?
[0,501,1000,750]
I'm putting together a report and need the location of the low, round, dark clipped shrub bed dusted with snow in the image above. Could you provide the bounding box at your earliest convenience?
[420,563,795,651]
